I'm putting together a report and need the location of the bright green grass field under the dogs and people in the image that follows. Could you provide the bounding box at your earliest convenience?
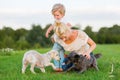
[0,44,120,80]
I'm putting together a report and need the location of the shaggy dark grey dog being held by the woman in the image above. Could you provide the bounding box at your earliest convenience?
[66,52,101,73]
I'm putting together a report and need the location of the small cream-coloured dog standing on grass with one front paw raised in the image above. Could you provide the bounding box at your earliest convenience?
[22,50,60,74]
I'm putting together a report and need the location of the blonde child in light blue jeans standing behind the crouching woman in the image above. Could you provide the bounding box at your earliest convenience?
[46,3,71,71]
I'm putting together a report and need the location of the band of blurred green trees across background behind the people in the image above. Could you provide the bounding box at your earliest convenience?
[0,24,120,49]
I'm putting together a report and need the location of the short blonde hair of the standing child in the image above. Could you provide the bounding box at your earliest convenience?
[51,3,65,15]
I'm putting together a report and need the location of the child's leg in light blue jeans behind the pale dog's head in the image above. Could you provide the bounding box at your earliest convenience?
[53,43,65,68]
